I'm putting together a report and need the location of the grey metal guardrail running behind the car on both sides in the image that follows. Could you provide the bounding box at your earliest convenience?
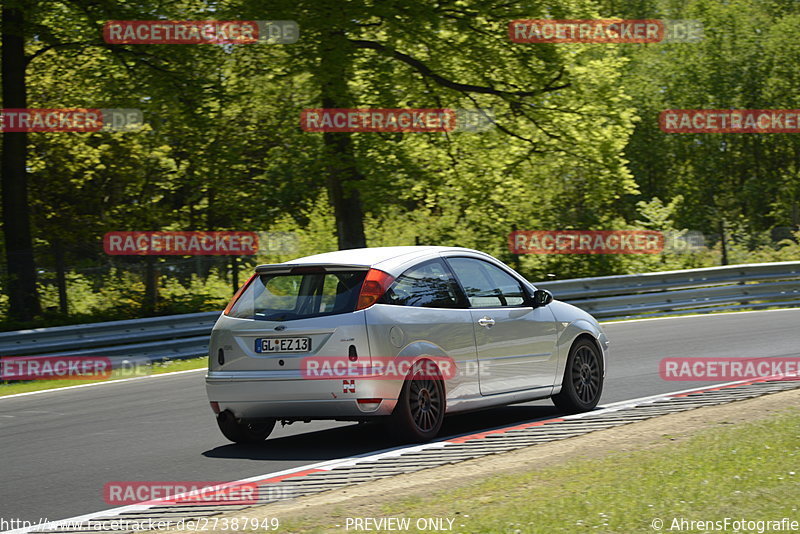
[0,261,800,362]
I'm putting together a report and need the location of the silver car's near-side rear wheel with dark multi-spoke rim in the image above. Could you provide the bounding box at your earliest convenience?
[386,360,446,442]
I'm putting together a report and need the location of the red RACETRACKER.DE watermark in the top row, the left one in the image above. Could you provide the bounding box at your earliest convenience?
[103,20,300,44]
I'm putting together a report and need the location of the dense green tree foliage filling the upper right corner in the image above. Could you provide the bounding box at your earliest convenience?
[625,0,800,244]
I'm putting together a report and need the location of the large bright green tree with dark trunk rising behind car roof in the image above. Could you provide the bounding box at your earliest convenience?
[228,0,633,248]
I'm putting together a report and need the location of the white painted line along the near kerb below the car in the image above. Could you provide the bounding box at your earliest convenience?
[8,371,768,534]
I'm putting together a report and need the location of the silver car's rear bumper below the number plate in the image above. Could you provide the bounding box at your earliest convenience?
[206,371,403,419]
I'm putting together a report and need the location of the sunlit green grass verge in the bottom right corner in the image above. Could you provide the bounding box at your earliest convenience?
[281,411,800,534]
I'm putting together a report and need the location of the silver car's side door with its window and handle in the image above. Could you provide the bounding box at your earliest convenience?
[447,257,557,395]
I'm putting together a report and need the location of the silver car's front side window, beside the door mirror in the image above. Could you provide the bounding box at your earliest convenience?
[447,258,527,308]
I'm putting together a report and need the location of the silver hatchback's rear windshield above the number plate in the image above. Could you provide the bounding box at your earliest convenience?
[228,271,367,321]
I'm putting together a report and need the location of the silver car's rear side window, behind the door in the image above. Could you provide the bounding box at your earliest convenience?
[380,260,463,308]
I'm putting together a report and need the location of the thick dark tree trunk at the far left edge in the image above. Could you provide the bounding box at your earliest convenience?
[0,8,41,321]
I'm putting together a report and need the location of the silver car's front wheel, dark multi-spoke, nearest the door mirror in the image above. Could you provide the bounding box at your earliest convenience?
[553,338,603,413]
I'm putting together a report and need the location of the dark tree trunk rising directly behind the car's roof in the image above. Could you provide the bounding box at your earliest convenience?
[317,31,367,250]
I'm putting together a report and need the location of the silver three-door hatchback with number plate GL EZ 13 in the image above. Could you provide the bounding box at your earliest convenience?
[206,247,608,443]
